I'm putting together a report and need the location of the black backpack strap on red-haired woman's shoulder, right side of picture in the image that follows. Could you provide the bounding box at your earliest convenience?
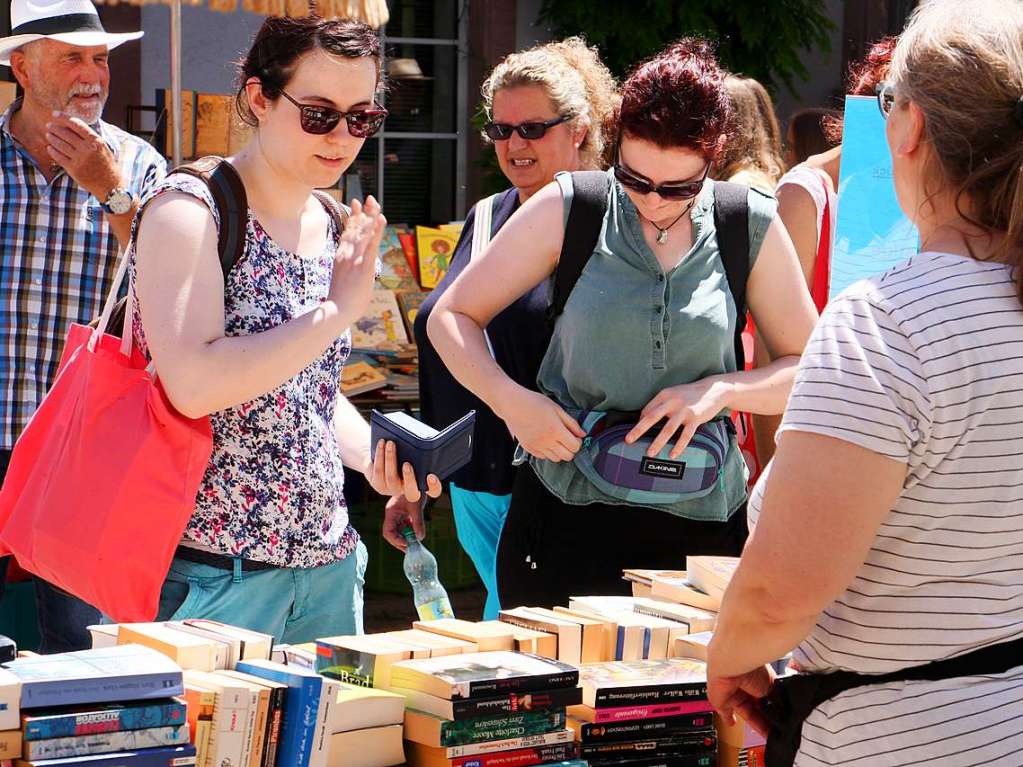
[714,181,750,370]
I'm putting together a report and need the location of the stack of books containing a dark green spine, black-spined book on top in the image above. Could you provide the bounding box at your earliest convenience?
[391,650,582,767]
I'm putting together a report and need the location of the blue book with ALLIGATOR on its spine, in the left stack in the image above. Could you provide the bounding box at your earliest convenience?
[21,697,187,740]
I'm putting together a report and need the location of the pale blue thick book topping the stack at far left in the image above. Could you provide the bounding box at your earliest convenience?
[4,644,184,709]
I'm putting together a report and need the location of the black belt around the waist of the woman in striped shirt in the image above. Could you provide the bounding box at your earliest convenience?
[763,638,1023,767]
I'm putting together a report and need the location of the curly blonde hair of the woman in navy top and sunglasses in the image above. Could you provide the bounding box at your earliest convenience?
[482,37,619,168]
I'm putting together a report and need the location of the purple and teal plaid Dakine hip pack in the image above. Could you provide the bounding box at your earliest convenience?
[572,410,735,504]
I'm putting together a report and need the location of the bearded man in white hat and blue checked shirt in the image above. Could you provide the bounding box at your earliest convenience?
[0,0,166,652]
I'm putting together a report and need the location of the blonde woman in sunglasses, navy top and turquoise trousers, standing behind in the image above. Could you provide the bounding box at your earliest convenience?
[414,38,617,620]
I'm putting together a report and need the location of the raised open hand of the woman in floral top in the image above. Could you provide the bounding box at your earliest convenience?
[327,196,387,315]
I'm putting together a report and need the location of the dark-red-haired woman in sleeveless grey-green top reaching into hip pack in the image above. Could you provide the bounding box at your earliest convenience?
[430,40,816,604]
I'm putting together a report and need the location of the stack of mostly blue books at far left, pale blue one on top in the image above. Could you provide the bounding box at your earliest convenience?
[0,644,196,767]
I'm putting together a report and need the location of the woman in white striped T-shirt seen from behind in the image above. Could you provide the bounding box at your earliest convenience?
[708,0,1023,767]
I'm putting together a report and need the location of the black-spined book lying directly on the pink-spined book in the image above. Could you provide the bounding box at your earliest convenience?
[579,658,707,709]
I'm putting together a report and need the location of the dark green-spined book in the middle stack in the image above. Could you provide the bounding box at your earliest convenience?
[405,709,566,747]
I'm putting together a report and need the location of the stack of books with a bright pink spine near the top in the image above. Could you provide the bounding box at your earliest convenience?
[569,659,717,767]
